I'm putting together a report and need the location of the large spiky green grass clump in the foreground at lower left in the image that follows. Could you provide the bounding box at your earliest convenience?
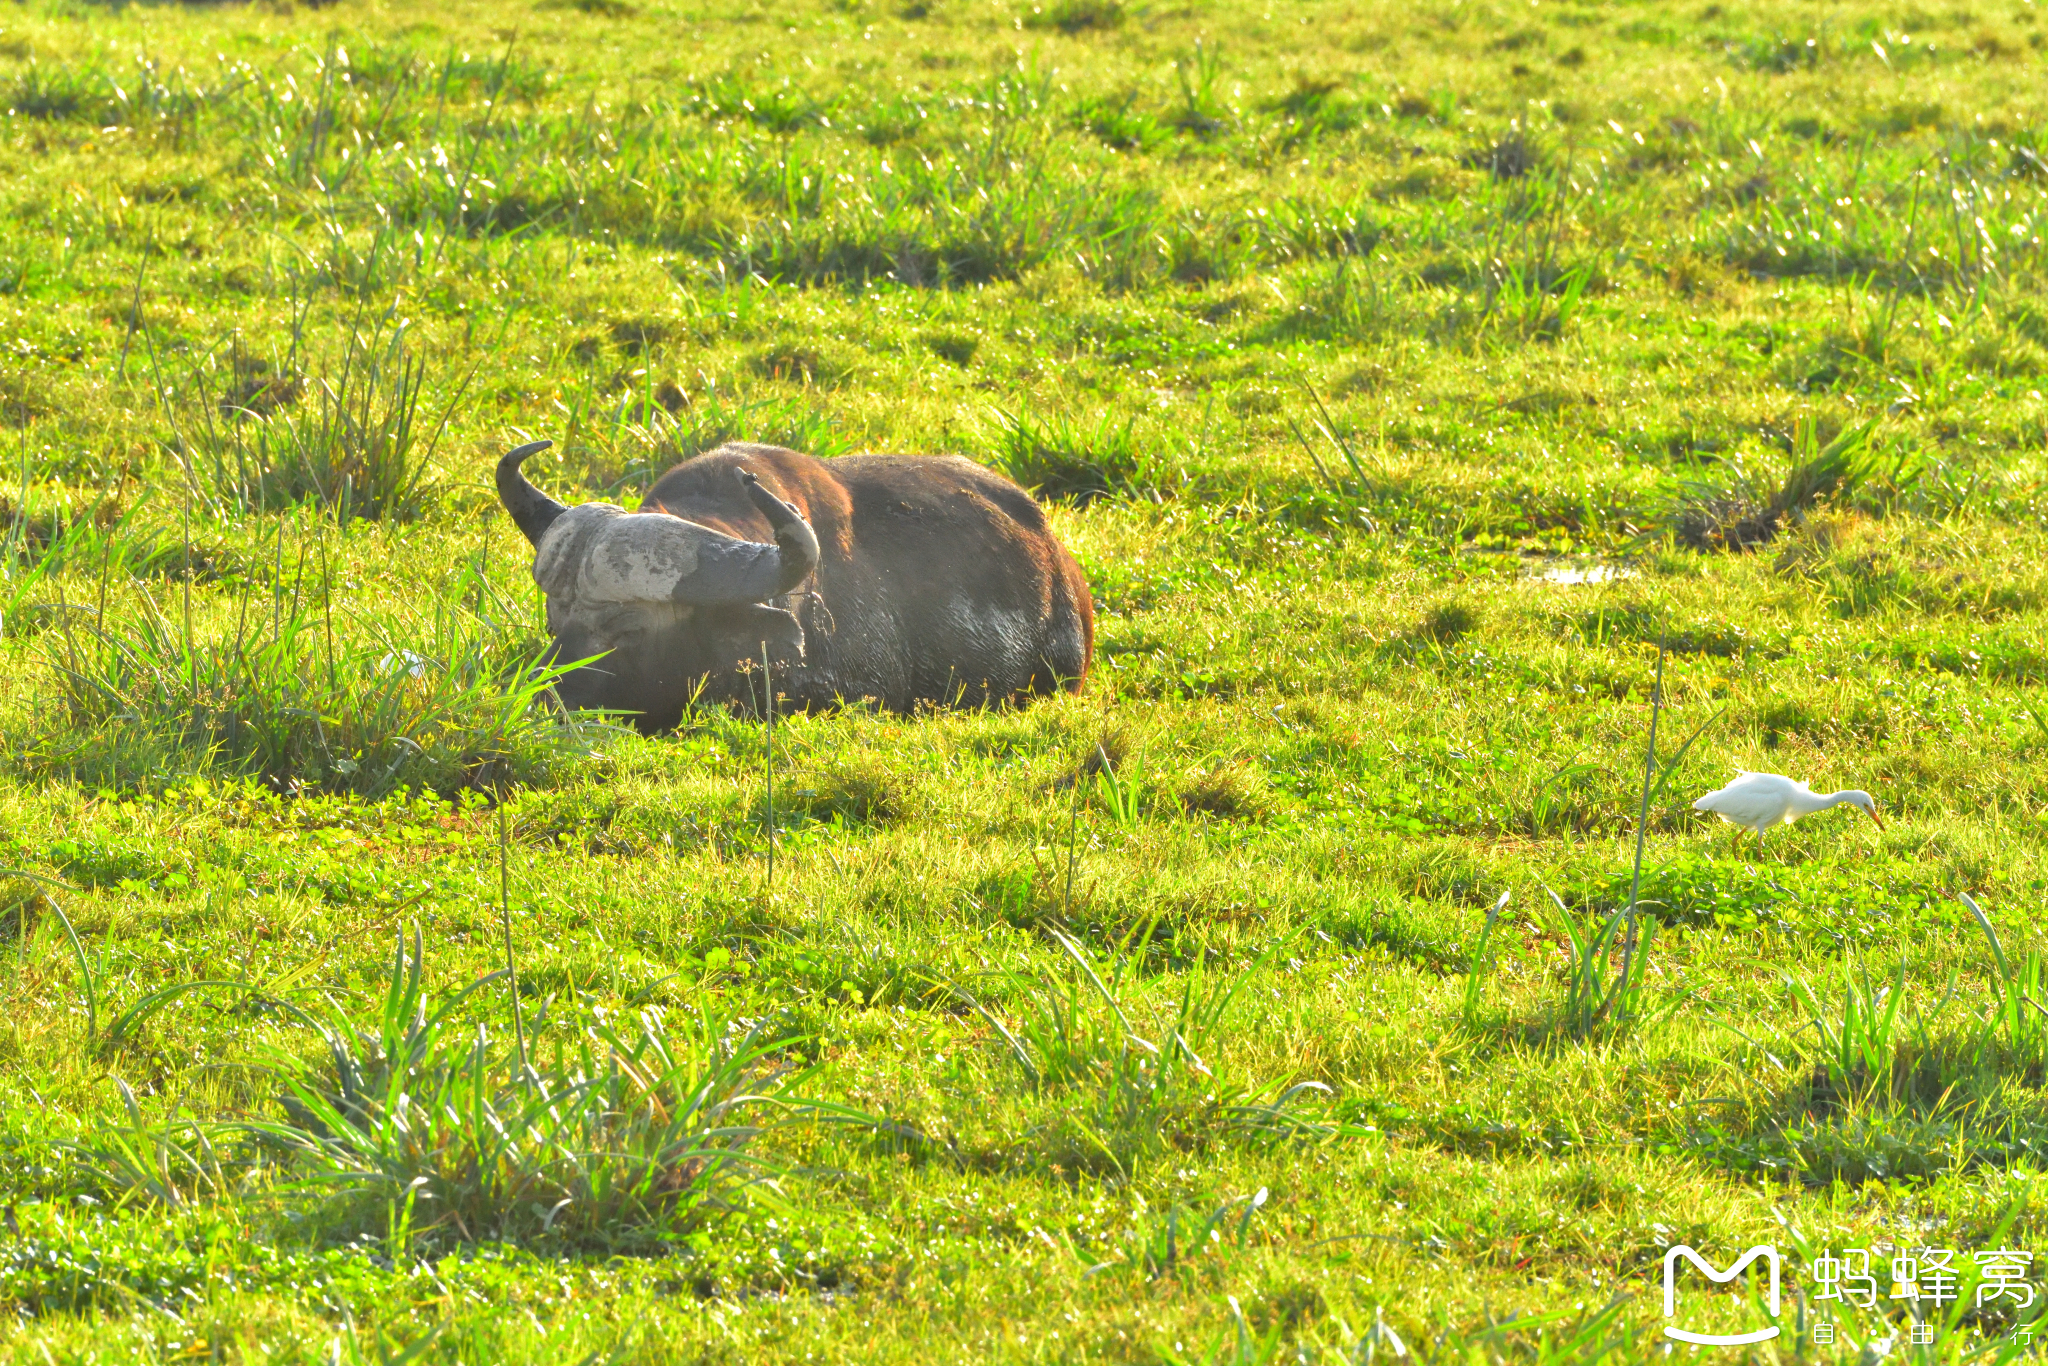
[250,940,791,1245]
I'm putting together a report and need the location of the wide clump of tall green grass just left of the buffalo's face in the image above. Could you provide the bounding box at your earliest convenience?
[23,551,606,797]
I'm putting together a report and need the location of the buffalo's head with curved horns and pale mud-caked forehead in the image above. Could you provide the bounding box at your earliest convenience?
[498,440,817,731]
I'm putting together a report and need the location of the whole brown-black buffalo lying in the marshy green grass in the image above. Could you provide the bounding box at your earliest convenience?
[498,440,1096,733]
